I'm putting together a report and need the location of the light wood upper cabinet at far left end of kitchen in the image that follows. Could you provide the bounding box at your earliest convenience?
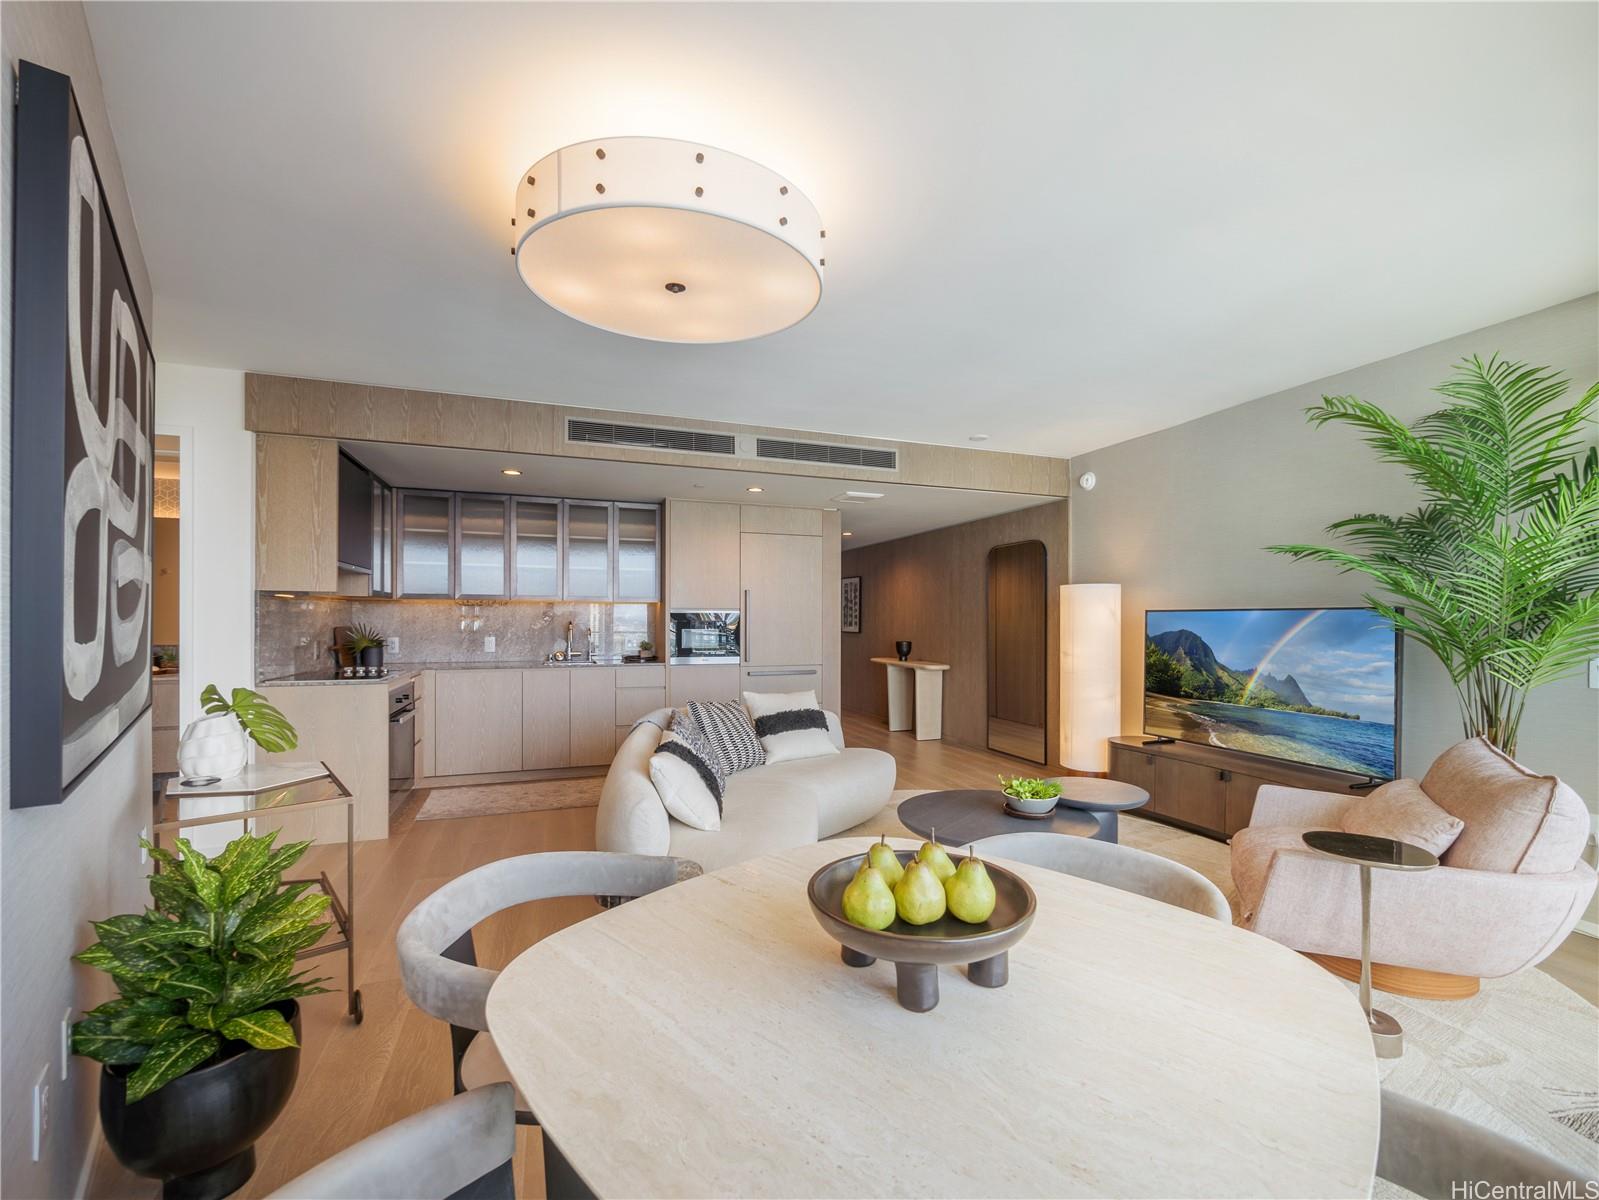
[256,434,339,592]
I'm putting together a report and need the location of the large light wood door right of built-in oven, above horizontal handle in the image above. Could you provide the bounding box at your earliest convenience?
[739,533,823,666]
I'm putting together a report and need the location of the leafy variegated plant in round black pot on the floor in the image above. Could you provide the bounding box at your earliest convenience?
[72,834,329,1198]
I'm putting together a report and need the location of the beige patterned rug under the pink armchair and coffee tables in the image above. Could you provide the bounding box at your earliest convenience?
[839,792,1599,1177]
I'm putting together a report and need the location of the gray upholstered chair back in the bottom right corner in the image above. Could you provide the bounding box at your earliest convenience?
[1377,1088,1599,1200]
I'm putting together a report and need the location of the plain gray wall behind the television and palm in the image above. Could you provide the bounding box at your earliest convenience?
[1070,294,1599,808]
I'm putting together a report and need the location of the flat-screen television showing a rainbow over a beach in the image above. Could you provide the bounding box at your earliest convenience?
[1143,608,1401,779]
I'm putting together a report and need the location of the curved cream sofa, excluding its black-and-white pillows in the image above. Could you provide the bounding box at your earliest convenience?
[595,709,894,870]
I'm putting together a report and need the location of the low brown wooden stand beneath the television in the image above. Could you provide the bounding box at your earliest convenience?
[1110,738,1382,840]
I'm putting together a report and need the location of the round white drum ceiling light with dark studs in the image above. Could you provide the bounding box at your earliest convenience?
[512,138,827,342]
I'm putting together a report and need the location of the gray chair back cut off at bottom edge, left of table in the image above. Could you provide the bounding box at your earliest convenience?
[267,1083,516,1200]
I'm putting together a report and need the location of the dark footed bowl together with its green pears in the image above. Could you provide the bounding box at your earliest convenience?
[806,830,1038,1013]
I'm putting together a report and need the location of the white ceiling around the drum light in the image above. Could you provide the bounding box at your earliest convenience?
[86,3,1599,454]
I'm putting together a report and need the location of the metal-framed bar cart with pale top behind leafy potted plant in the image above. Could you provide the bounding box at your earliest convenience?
[152,762,363,1024]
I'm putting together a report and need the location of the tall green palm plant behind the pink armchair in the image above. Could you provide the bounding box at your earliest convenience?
[1268,355,1599,755]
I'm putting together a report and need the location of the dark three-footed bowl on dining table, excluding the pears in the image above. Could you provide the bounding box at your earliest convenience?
[806,850,1038,1013]
